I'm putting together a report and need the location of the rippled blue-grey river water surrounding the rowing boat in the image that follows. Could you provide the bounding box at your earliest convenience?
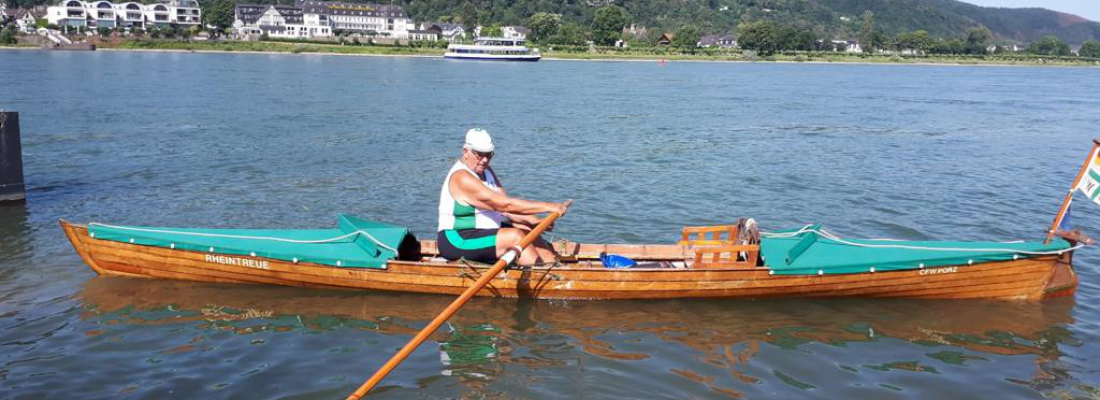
[0,51,1100,399]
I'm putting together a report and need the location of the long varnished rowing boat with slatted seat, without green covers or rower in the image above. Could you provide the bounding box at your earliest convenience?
[61,220,1077,300]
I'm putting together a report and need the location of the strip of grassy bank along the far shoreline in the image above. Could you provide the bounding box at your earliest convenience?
[0,38,1100,67]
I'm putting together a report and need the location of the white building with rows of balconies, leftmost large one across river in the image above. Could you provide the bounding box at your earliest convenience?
[46,0,202,27]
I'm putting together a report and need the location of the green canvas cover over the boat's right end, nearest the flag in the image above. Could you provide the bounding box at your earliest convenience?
[760,225,1069,275]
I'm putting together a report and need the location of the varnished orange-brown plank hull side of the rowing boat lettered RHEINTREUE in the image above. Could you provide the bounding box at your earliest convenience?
[62,221,1077,300]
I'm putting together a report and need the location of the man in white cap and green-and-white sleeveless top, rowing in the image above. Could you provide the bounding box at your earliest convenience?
[439,127,569,265]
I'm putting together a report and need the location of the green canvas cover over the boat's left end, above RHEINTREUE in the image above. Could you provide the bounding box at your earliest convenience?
[88,214,408,269]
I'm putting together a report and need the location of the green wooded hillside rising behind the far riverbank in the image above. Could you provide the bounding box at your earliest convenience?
[10,0,1100,46]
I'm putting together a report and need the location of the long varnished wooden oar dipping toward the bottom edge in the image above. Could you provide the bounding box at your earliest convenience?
[348,206,572,400]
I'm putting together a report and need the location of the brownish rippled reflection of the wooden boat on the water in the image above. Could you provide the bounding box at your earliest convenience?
[79,277,1075,397]
